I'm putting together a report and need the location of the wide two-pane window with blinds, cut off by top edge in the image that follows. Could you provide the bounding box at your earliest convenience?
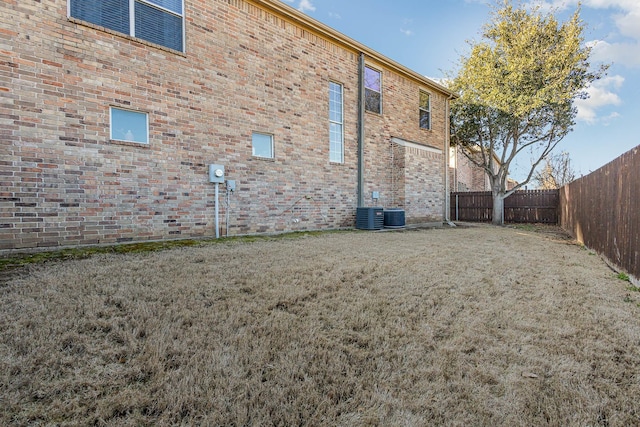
[69,0,184,52]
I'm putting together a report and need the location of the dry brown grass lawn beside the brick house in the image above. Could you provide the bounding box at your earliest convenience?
[0,226,640,426]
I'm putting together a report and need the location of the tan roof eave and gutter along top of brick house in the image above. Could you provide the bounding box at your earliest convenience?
[248,0,458,98]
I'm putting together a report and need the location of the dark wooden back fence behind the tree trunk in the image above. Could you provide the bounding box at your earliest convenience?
[451,190,560,224]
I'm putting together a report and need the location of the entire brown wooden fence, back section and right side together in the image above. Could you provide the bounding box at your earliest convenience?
[451,146,640,283]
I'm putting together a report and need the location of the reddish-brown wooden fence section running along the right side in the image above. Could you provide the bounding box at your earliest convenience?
[560,146,640,279]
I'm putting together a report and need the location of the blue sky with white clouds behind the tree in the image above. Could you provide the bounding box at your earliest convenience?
[284,0,640,179]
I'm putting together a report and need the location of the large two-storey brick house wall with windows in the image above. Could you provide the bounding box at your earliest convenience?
[0,0,454,250]
